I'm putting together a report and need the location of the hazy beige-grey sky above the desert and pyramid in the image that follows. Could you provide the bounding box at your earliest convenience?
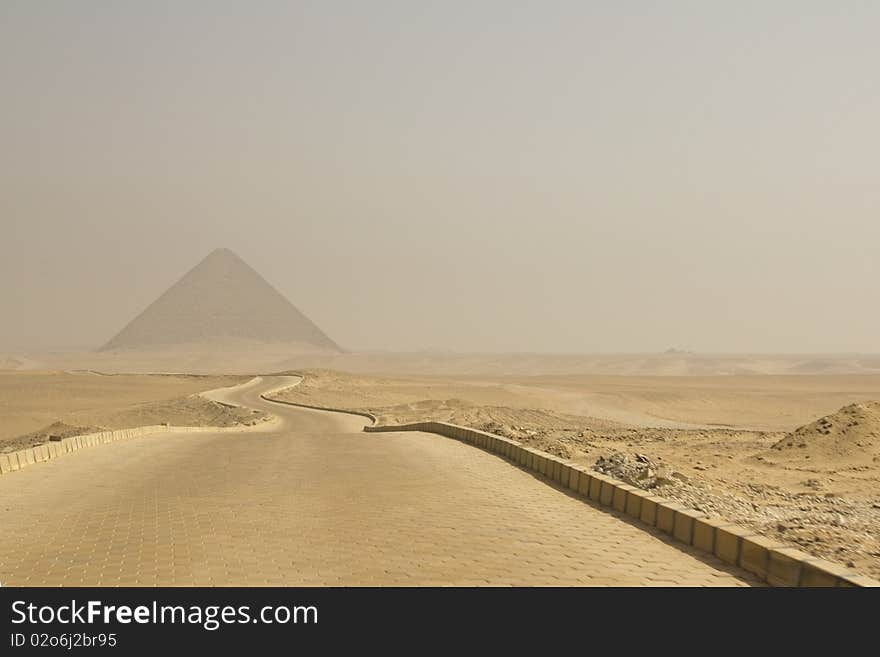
[0,0,880,352]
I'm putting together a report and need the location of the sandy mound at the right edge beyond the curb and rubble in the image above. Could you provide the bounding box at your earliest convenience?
[773,401,880,466]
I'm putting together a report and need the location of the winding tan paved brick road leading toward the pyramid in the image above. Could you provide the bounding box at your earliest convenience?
[0,379,753,586]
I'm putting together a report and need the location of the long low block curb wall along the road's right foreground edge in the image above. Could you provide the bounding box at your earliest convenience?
[364,422,880,587]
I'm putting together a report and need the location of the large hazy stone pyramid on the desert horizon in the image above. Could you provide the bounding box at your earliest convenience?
[100,249,340,351]
